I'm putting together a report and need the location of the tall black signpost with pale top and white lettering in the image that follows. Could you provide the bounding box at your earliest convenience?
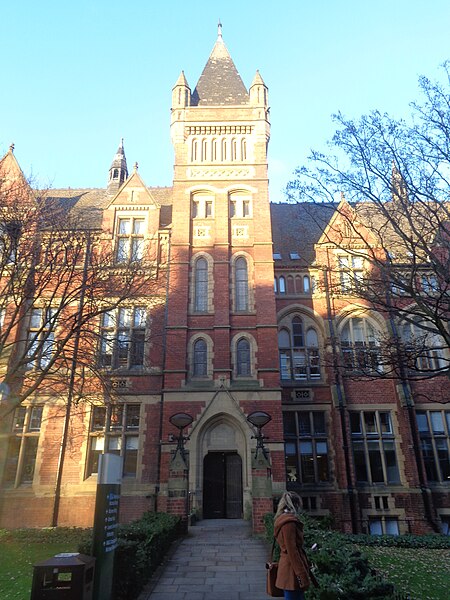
[92,454,122,600]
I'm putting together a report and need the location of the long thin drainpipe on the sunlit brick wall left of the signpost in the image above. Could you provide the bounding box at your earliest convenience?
[52,232,92,527]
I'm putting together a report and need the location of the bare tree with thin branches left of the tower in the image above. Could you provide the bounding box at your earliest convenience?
[0,169,165,419]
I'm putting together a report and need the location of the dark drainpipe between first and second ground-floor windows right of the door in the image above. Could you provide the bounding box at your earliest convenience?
[324,265,359,533]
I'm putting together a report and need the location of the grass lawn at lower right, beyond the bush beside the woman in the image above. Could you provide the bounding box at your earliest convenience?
[360,546,450,600]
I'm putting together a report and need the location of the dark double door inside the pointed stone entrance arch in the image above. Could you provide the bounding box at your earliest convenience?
[203,452,243,519]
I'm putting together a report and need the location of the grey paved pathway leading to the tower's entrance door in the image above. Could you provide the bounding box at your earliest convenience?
[139,519,268,600]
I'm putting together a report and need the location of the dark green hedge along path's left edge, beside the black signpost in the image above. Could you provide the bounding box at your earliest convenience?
[78,512,180,600]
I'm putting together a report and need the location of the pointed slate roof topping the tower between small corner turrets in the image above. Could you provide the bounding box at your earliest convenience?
[191,35,249,106]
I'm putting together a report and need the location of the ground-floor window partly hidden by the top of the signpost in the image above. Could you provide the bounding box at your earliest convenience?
[86,403,141,477]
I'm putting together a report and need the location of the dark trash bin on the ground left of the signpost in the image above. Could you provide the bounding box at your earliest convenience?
[30,552,95,600]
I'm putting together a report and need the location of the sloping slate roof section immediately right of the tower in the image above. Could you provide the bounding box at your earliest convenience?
[270,202,335,267]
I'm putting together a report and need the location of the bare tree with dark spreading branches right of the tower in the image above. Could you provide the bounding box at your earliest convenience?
[287,63,450,378]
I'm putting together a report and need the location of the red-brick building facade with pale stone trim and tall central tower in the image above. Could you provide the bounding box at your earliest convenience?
[0,27,450,534]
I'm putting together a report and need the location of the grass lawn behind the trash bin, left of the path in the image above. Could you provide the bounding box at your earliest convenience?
[0,536,86,600]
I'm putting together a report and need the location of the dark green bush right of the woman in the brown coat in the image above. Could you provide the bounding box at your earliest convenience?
[264,514,394,600]
